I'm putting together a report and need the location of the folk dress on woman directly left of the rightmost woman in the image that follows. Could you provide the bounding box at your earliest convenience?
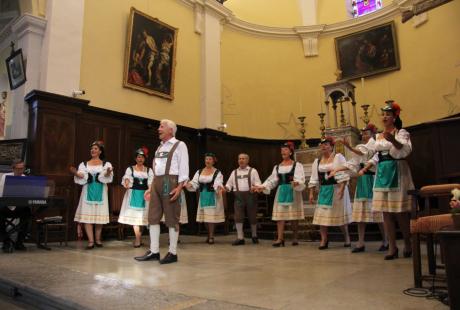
[344,138,383,223]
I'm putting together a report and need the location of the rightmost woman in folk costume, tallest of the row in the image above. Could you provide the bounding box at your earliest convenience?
[369,100,414,260]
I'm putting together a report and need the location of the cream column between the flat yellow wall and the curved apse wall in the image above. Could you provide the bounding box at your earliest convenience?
[194,0,231,129]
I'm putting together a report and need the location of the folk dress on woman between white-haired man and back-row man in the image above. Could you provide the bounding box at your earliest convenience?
[191,169,225,223]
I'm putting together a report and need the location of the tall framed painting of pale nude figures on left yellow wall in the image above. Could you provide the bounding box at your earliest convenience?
[123,8,178,100]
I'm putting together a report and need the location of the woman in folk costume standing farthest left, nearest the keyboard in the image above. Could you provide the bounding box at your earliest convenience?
[70,141,113,249]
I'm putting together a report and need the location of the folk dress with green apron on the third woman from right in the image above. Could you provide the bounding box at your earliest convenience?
[308,153,351,226]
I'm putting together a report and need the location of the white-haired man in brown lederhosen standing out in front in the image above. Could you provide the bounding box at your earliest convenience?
[135,120,189,264]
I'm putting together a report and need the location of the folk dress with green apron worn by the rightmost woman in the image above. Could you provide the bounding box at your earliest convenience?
[369,129,414,213]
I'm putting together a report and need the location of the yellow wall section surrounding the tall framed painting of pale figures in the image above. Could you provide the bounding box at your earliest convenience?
[80,0,201,127]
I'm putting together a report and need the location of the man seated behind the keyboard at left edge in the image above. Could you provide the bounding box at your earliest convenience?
[0,159,30,253]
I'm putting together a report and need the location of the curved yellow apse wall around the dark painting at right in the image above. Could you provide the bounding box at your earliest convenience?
[222,1,460,138]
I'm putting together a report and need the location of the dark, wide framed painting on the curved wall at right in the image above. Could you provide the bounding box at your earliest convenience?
[335,22,400,79]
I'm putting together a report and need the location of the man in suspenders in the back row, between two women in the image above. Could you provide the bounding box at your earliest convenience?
[225,153,261,245]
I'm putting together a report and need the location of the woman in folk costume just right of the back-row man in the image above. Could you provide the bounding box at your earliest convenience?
[257,142,305,247]
